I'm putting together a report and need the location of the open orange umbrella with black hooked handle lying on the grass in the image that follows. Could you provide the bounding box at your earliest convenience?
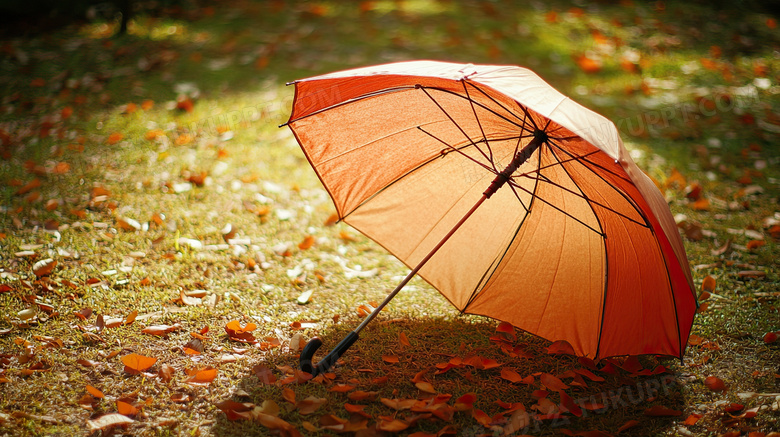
[283,61,697,374]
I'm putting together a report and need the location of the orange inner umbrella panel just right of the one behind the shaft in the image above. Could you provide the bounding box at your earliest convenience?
[466,147,606,356]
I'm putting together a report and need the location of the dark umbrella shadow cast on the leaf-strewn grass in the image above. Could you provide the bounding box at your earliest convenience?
[213,317,686,435]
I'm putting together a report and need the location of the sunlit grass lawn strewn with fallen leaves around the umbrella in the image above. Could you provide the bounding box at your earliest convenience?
[0,1,780,436]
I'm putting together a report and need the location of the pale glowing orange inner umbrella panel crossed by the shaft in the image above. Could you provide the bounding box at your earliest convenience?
[345,143,533,309]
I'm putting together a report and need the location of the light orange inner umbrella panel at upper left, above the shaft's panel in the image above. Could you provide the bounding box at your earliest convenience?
[291,84,532,217]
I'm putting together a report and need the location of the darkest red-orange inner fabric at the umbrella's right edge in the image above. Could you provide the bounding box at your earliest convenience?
[564,145,695,356]
